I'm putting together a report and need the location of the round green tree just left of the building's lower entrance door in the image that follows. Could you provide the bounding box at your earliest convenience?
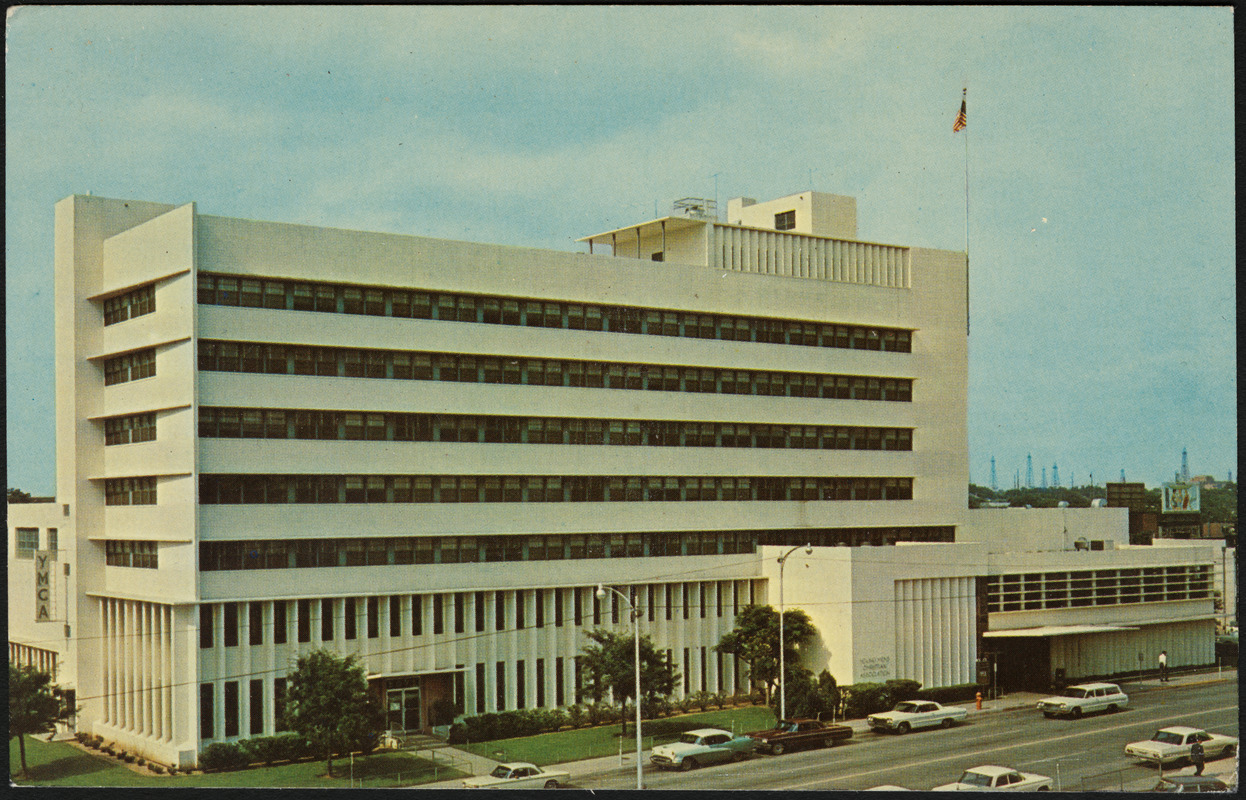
[285,649,383,778]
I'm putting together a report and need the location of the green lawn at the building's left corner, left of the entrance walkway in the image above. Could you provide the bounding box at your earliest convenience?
[9,736,464,789]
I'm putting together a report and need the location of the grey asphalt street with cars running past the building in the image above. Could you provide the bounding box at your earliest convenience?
[572,682,1239,791]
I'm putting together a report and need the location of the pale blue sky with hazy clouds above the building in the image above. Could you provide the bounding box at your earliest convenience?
[5,6,1237,495]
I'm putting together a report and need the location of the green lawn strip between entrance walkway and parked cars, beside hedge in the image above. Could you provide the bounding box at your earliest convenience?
[456,705,775,766]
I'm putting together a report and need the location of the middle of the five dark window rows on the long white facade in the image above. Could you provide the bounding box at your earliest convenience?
[194,406,913,450]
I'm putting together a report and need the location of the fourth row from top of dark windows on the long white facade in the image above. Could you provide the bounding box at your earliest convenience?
[196,475,913,505]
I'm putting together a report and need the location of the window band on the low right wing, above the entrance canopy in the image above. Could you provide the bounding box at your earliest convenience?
[987,564,1211,612]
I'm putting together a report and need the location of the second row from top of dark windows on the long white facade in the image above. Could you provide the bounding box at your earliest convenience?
[199,340,913,402]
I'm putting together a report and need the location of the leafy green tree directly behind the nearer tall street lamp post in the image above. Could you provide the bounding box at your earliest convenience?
[579,628,679,736]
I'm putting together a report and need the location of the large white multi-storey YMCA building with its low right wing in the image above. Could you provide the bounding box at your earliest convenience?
[7,192,1215,765]
